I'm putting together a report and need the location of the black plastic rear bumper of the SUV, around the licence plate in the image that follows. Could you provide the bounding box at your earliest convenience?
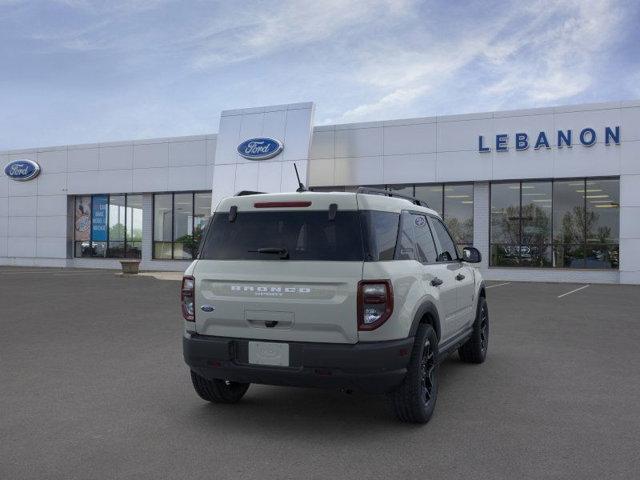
[182,332,414,393]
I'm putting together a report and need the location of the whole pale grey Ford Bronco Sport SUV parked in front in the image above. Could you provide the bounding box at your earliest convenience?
[181,189,489,423]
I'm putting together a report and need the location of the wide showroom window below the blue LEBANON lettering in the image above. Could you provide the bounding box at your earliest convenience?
[490,178,620,269]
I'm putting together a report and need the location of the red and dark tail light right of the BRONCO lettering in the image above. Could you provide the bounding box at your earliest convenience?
[358,280,393,330]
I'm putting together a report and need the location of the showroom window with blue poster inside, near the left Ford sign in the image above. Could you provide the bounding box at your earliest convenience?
[74,194,142,258]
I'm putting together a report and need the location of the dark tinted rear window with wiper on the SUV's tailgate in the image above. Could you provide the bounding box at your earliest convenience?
[200,210,364,261]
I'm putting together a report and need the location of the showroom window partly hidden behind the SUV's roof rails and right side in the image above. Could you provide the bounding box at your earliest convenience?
[312,183,473,248]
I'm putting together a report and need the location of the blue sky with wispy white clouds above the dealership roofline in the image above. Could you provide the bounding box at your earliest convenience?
[0,0,640,150]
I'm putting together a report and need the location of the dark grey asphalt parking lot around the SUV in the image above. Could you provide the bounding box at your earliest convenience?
[0,267,640,479]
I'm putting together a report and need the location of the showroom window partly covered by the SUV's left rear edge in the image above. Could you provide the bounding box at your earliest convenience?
[153,192,211,260]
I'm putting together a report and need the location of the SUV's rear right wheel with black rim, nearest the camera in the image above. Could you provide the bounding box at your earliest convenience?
[388,324,438,423]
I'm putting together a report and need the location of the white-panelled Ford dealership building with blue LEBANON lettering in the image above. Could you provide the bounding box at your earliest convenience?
[0,101,640,284]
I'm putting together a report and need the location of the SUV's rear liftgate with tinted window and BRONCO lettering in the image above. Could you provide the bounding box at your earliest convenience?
[194,194,364,343]
